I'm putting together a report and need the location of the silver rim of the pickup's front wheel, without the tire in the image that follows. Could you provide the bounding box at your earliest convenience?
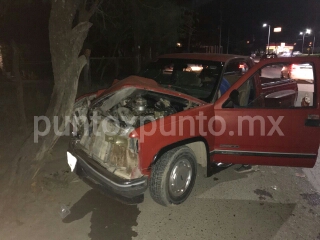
[169,159,192,197]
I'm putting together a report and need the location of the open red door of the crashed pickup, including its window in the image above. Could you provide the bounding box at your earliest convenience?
[210,57,320,167]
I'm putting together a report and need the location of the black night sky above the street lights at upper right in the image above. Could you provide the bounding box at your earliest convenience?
[192,0,320,46]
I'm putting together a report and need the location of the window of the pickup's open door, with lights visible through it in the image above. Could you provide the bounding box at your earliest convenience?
[224,63,315,108]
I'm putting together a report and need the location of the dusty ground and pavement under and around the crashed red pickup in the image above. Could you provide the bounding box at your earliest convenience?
[0,81,320,240]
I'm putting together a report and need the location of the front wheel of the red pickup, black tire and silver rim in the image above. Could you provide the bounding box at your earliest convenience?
[149,146,197,206]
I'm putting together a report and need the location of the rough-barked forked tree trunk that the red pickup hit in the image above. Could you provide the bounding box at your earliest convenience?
[36,0,92,160]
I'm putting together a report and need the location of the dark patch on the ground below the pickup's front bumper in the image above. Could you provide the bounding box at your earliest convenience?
[63,189,140,240]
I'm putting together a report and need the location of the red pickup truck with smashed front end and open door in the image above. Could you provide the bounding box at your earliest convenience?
[67,54,320,206]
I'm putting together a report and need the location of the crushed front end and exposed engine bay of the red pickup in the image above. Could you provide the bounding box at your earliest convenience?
[73,87,197,179]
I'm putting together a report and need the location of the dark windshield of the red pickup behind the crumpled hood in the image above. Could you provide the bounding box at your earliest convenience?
[139,58,223,101]
